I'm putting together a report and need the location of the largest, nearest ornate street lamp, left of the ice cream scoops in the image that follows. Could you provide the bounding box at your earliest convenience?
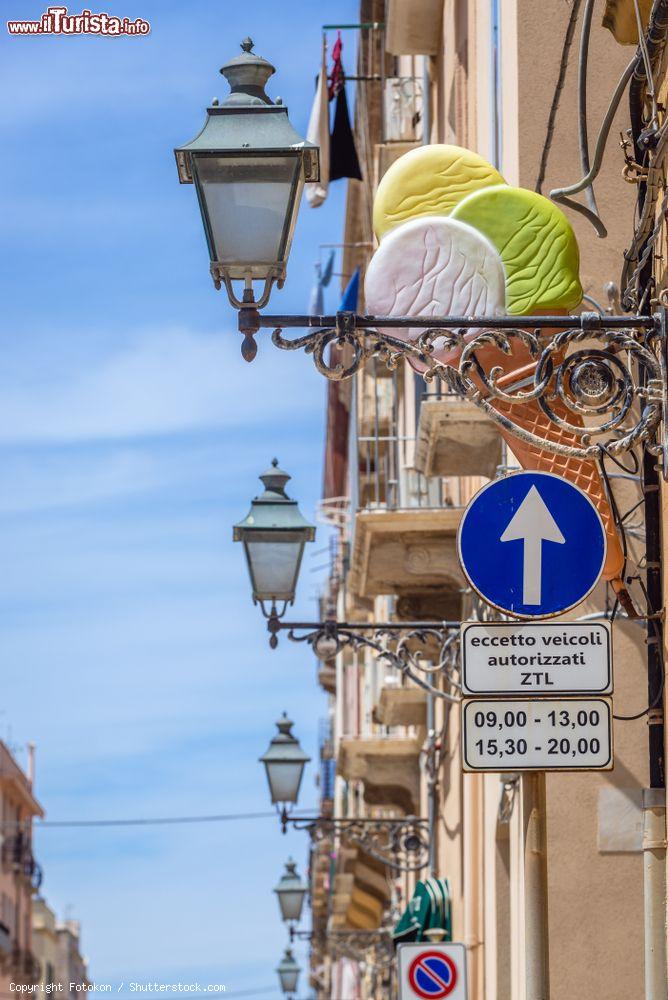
[174,38,320,361]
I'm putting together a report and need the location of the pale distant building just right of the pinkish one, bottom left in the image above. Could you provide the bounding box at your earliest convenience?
[32,896,90,997]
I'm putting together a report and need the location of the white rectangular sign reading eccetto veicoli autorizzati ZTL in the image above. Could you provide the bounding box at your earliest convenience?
[460,622,612,695]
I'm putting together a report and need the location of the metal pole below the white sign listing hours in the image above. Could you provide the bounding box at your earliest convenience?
[522,771,550,1000]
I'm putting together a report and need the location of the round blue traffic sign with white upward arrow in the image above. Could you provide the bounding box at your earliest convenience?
[457,472,606,618]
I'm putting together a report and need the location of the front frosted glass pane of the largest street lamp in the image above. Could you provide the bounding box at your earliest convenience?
[197,156,300,264]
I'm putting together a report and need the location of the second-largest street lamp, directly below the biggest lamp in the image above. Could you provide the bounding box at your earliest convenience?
[233,459,315,646]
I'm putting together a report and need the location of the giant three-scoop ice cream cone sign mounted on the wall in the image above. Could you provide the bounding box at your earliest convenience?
[365,145,624,581]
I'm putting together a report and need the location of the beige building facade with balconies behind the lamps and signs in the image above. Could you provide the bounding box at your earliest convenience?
[310,0,668,1000]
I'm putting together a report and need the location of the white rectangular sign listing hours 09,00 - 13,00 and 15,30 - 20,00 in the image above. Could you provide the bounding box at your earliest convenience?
[462,698,613,771]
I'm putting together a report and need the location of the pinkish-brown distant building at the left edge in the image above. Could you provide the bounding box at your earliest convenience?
[0,740,44,995]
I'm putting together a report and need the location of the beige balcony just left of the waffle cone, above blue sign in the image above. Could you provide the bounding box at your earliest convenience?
[415,394,502,479]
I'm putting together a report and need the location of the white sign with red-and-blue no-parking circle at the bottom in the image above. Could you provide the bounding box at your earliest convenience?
[397,941,468,1000]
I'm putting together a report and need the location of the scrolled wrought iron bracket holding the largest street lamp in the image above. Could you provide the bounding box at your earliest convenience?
[240,307,668,466]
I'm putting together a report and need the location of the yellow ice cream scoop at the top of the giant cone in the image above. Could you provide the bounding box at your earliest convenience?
[373,144,505,240]
